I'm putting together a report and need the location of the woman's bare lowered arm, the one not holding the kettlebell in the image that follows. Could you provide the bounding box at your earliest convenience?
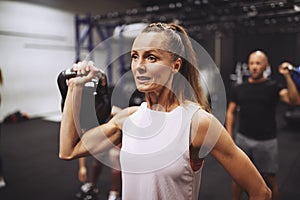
[192,113,271,200]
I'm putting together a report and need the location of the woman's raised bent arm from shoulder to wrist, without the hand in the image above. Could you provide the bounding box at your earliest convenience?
[59,81,138,160]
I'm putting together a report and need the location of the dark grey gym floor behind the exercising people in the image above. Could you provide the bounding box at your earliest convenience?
[0,110,300,200]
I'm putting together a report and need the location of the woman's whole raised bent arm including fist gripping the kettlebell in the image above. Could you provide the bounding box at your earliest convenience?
[59,62,136,160]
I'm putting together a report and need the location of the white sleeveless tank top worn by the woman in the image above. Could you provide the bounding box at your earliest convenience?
[120,103,202,200]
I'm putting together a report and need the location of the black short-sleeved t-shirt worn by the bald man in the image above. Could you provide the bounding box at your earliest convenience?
[230,80,283,140]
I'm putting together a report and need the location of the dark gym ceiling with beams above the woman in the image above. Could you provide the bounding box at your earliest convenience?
[0,0,300,34]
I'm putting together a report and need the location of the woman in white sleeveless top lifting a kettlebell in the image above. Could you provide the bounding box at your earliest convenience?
[60,23,271,200]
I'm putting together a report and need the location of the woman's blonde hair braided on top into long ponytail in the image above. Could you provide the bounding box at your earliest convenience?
[142,22,211,112]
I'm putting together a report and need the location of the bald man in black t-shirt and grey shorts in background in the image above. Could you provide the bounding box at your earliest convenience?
[226,51,299,200]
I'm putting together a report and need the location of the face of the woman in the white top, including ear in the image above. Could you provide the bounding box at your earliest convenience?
[131,32,181,92]
